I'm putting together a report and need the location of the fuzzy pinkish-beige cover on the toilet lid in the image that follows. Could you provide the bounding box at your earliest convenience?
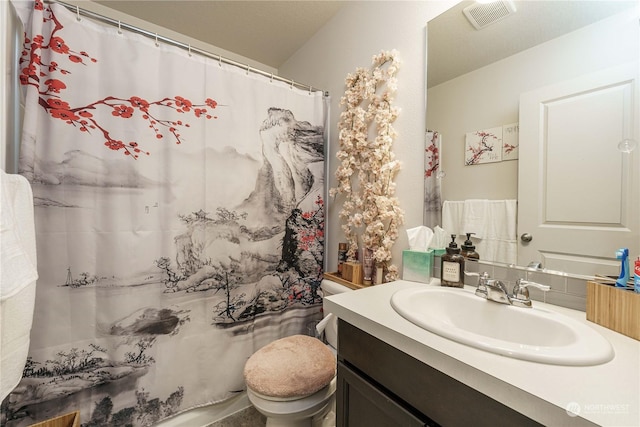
[244,335,336,398]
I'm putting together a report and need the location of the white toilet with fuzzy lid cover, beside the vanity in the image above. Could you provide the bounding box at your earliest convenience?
[244,280,351,427]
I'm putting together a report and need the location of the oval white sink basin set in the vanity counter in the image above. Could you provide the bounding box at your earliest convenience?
[391,287,614,366]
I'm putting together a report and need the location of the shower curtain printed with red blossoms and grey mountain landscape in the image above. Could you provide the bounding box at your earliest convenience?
[0,1,327,427]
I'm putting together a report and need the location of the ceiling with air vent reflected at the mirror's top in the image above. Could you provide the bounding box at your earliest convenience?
[427,0,639,87]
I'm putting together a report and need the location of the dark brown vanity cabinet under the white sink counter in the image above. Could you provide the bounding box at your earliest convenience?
[336,319,541,427]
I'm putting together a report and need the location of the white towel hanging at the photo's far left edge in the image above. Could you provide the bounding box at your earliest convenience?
[0,170,38,400]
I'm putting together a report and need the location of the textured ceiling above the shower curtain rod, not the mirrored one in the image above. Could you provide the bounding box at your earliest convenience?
[94,0,344,68]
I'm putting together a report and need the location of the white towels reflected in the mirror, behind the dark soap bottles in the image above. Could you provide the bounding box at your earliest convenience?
[442,199,518,264]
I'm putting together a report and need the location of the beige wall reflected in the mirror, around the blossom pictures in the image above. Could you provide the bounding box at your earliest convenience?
[427,9,640,200]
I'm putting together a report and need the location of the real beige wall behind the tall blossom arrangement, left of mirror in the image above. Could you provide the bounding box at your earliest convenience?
[279,0,457,271]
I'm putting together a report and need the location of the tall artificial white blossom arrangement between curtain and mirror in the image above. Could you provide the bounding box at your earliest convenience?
[330,50,404,281]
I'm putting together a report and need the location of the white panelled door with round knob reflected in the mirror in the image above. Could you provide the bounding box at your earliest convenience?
[518,62,640,275]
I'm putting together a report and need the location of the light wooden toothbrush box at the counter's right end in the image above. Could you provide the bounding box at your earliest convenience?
[587,282,640,340]
